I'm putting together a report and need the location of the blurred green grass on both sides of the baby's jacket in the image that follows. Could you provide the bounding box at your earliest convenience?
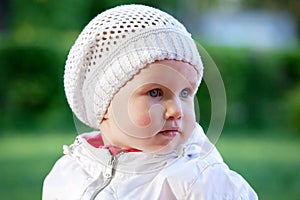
[0,132,300,200]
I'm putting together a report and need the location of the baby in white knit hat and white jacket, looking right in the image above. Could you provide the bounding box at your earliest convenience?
[43,5,257,200]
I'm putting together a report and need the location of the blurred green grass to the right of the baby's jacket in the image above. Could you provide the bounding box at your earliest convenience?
[217,134,300,200]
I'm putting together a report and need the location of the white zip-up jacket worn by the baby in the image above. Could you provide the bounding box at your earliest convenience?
[43,125,258,200]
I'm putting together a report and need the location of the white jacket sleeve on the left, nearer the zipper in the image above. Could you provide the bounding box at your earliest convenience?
[42,155,90,200]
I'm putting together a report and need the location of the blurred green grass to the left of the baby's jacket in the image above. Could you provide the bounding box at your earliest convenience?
[0,133,75,200]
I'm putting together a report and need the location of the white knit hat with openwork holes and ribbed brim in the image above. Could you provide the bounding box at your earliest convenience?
[64,5,203,129]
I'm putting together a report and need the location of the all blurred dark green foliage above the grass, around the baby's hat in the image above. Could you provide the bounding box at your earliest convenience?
[0,0,300,134]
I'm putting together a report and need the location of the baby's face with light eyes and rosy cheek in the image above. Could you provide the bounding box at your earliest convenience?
[101,60,197,153]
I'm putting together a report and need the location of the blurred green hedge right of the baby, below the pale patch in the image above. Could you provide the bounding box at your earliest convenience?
[198,46,300,131]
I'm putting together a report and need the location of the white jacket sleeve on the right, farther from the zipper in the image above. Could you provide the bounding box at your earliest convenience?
[187,163,258,200]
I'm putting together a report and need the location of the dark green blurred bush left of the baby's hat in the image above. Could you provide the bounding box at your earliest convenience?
[0,44,68,129]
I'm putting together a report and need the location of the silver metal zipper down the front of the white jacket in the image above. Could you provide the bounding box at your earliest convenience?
[91,152,123,200]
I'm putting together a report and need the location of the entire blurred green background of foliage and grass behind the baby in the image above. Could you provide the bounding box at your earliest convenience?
[0,0,300,200]
